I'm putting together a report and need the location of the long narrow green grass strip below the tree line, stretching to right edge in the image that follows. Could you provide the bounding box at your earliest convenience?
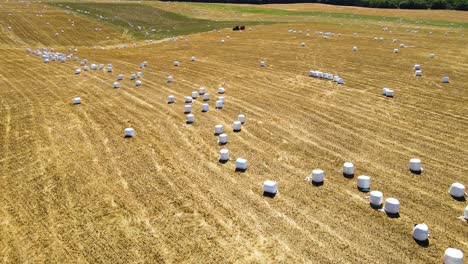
[193,3,468,28]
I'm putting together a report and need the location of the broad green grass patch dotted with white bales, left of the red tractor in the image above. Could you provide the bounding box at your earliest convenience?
[49,2,265,40]
